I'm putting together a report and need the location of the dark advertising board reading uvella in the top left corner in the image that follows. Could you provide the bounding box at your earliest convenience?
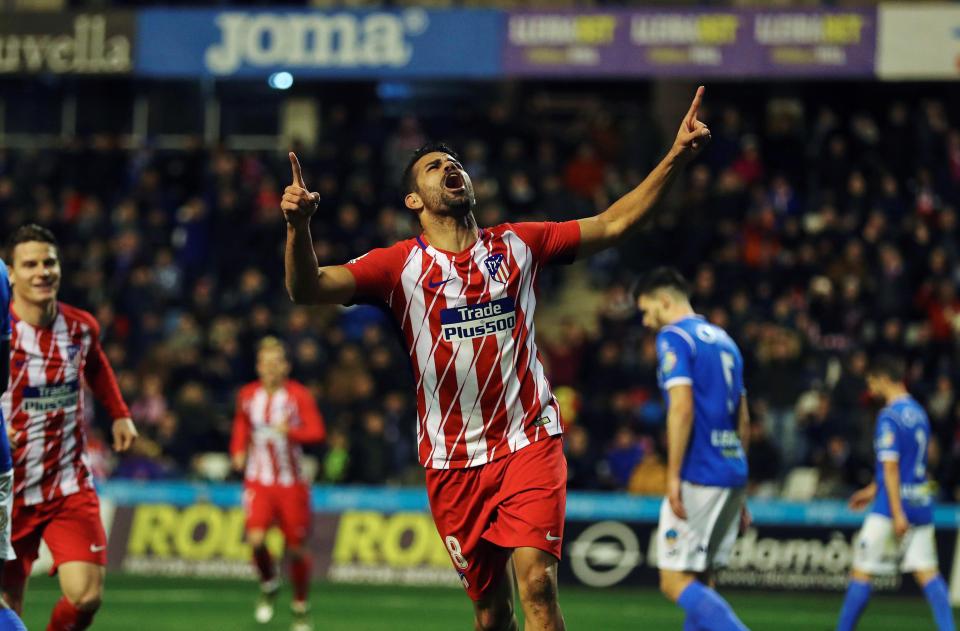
[0,11,136,77]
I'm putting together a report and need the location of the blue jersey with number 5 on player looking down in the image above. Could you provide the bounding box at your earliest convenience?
[657,316,747,487]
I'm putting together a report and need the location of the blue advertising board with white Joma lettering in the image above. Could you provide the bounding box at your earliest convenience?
[137,9,503,78]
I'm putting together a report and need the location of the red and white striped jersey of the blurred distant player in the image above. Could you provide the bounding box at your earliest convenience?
[230,380,326,486]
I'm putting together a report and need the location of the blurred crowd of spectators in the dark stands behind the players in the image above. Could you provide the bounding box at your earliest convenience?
[0,85,960,500]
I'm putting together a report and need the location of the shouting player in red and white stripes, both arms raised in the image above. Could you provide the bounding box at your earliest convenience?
[281,87,710,631]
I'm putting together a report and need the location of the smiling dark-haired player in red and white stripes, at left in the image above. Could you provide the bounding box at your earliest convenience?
[0,225,137,631]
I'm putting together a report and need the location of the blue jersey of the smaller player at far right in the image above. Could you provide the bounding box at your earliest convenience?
[873,395,933,526]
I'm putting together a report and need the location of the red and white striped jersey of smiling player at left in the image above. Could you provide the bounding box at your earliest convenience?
[0,303,130,506]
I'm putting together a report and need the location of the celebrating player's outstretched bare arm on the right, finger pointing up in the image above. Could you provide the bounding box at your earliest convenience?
[579,86,710,257]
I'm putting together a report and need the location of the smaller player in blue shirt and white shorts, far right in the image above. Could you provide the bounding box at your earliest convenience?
[837,357,954,631]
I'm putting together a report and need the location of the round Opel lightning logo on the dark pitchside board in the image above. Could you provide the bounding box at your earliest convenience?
[570,521,642,587]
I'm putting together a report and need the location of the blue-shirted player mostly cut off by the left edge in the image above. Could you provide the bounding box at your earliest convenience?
[0,260,26,631]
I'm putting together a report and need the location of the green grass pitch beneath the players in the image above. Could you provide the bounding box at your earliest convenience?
[18,575,948,631]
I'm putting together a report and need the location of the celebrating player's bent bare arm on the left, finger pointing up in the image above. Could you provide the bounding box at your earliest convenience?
[280,152,356,305]
